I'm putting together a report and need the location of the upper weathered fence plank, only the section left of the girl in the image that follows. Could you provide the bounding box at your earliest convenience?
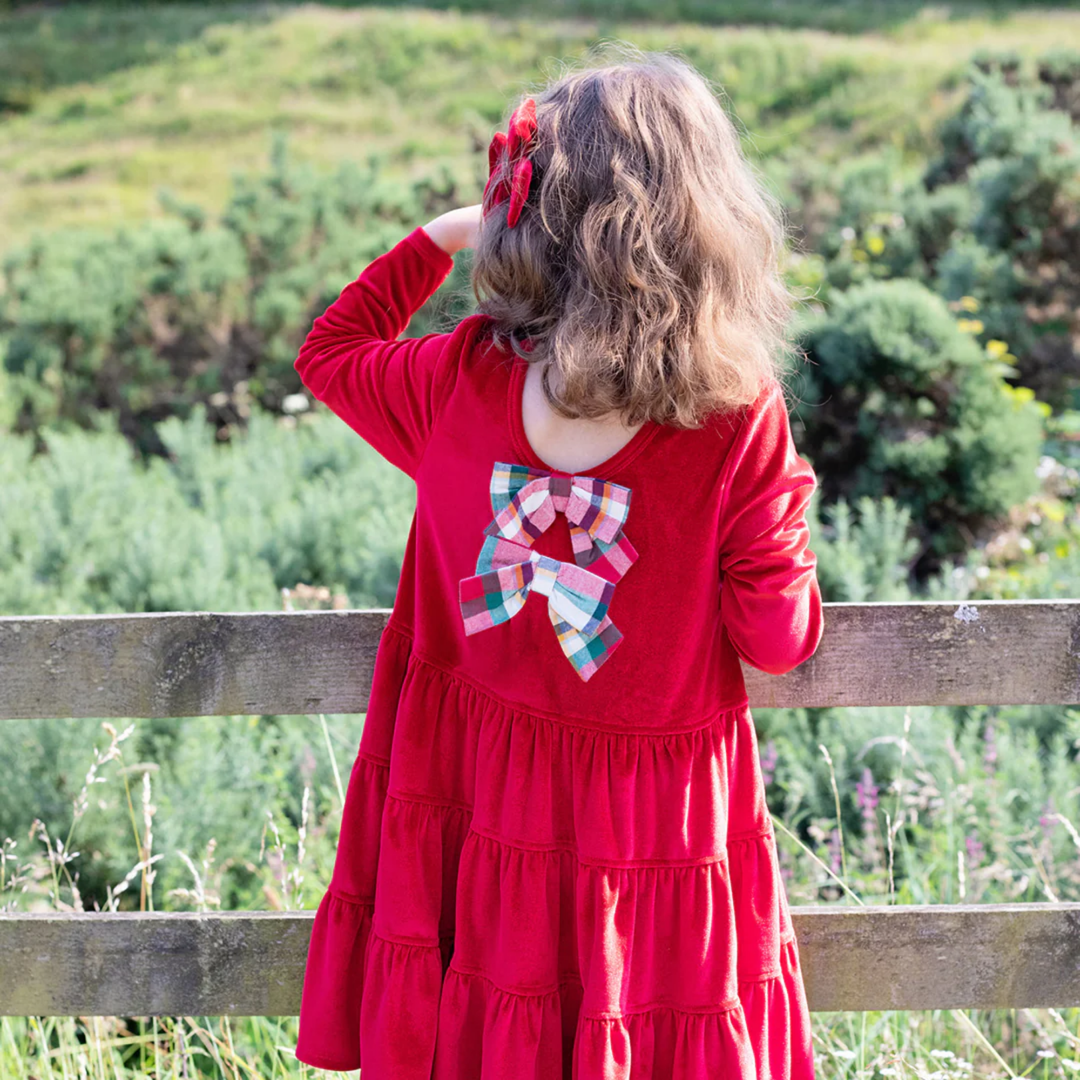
[0,609,390,719]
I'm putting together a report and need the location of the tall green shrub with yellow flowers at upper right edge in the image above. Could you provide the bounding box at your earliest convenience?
[804,53,1080,407]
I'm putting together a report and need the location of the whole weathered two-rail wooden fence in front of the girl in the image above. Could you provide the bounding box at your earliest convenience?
[0,600,1080,1016]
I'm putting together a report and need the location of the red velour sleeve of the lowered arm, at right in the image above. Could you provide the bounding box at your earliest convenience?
[720,375,823,675]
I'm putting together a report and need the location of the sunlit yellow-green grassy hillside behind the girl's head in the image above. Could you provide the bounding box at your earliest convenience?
[0,2,1080,251]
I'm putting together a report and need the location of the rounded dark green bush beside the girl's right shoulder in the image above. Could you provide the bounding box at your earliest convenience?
[796,280,1041,570]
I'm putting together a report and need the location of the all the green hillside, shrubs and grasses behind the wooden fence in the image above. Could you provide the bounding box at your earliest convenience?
[0,0,1080,1080]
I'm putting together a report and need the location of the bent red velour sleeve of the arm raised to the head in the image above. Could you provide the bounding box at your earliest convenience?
[295,223,457,476]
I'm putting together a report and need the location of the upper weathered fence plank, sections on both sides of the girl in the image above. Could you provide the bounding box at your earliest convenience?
[0,600,1080,718]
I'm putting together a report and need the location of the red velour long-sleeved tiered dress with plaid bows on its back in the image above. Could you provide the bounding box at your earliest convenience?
[296,223,822,1080]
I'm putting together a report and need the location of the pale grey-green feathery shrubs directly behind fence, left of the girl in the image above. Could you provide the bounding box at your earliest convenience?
[0,407,414,907]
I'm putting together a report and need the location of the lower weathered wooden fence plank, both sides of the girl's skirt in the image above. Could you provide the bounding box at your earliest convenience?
[0,904,1080,1016]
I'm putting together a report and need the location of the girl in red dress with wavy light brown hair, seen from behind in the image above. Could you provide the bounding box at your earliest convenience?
[296,46,822,1080]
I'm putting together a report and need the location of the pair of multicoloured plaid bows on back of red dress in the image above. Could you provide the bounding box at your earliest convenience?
[458,461,637,680]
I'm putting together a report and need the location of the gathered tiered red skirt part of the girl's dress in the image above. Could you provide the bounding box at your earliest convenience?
[297,624,813,1080]
